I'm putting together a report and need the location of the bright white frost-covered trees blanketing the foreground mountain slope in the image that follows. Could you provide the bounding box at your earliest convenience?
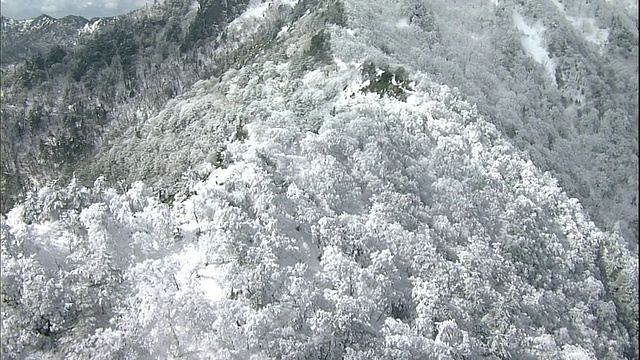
[3,60,637,358]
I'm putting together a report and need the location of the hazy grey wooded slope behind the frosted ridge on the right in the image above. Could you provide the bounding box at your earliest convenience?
[336,1,638,247]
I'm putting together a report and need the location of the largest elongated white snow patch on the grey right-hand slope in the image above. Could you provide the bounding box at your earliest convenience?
[513,12,556,84]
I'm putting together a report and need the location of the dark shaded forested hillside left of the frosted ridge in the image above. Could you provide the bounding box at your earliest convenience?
[1,1,255,211]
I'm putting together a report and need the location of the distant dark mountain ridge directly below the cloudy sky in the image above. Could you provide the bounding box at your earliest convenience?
[0,14,117,65]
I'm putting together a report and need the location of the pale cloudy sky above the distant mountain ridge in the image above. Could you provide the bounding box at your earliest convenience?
[1,0,153,19]
